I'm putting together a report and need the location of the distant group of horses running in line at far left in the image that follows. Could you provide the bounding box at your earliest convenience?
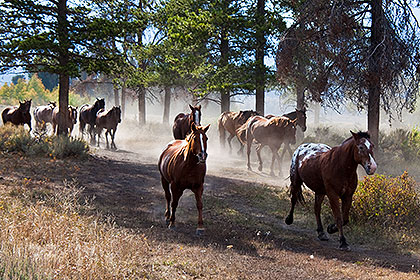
[2,98,121,149]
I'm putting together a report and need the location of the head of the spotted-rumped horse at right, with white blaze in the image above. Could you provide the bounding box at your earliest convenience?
[350,131,377,175]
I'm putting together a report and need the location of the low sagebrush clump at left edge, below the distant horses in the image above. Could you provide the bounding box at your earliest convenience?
[0,124,89,158]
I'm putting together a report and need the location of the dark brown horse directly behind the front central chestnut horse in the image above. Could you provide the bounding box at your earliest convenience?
[172,105,201,140]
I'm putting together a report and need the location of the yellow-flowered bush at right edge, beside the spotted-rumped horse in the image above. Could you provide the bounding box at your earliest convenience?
[351,172,420,229]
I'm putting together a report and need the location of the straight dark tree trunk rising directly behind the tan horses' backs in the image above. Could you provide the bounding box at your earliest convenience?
[255,0,266,115]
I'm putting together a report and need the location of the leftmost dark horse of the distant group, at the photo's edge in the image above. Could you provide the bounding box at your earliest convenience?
[1,99,32,131]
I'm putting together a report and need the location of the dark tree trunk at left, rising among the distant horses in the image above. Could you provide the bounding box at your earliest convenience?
[57,0,70,135]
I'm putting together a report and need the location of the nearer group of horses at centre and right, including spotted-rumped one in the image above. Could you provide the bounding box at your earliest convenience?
[163,105,377,251]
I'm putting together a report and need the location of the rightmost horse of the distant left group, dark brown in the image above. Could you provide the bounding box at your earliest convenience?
[95,106,121,150]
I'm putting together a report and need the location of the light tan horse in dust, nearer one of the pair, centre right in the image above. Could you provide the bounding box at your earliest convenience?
[241,116,296,175]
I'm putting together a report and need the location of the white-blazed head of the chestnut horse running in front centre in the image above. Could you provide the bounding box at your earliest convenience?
[186,123,210,163]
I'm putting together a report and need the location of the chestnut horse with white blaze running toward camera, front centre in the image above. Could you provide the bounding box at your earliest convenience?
[158,123,210,235]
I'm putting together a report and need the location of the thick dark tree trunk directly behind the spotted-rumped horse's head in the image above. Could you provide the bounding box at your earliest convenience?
[368,0,384,146]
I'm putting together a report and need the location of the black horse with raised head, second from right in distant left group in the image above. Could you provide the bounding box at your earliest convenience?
[79,98,105,143]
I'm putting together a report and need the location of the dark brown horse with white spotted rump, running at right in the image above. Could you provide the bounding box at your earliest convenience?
[285,132,377,250]
